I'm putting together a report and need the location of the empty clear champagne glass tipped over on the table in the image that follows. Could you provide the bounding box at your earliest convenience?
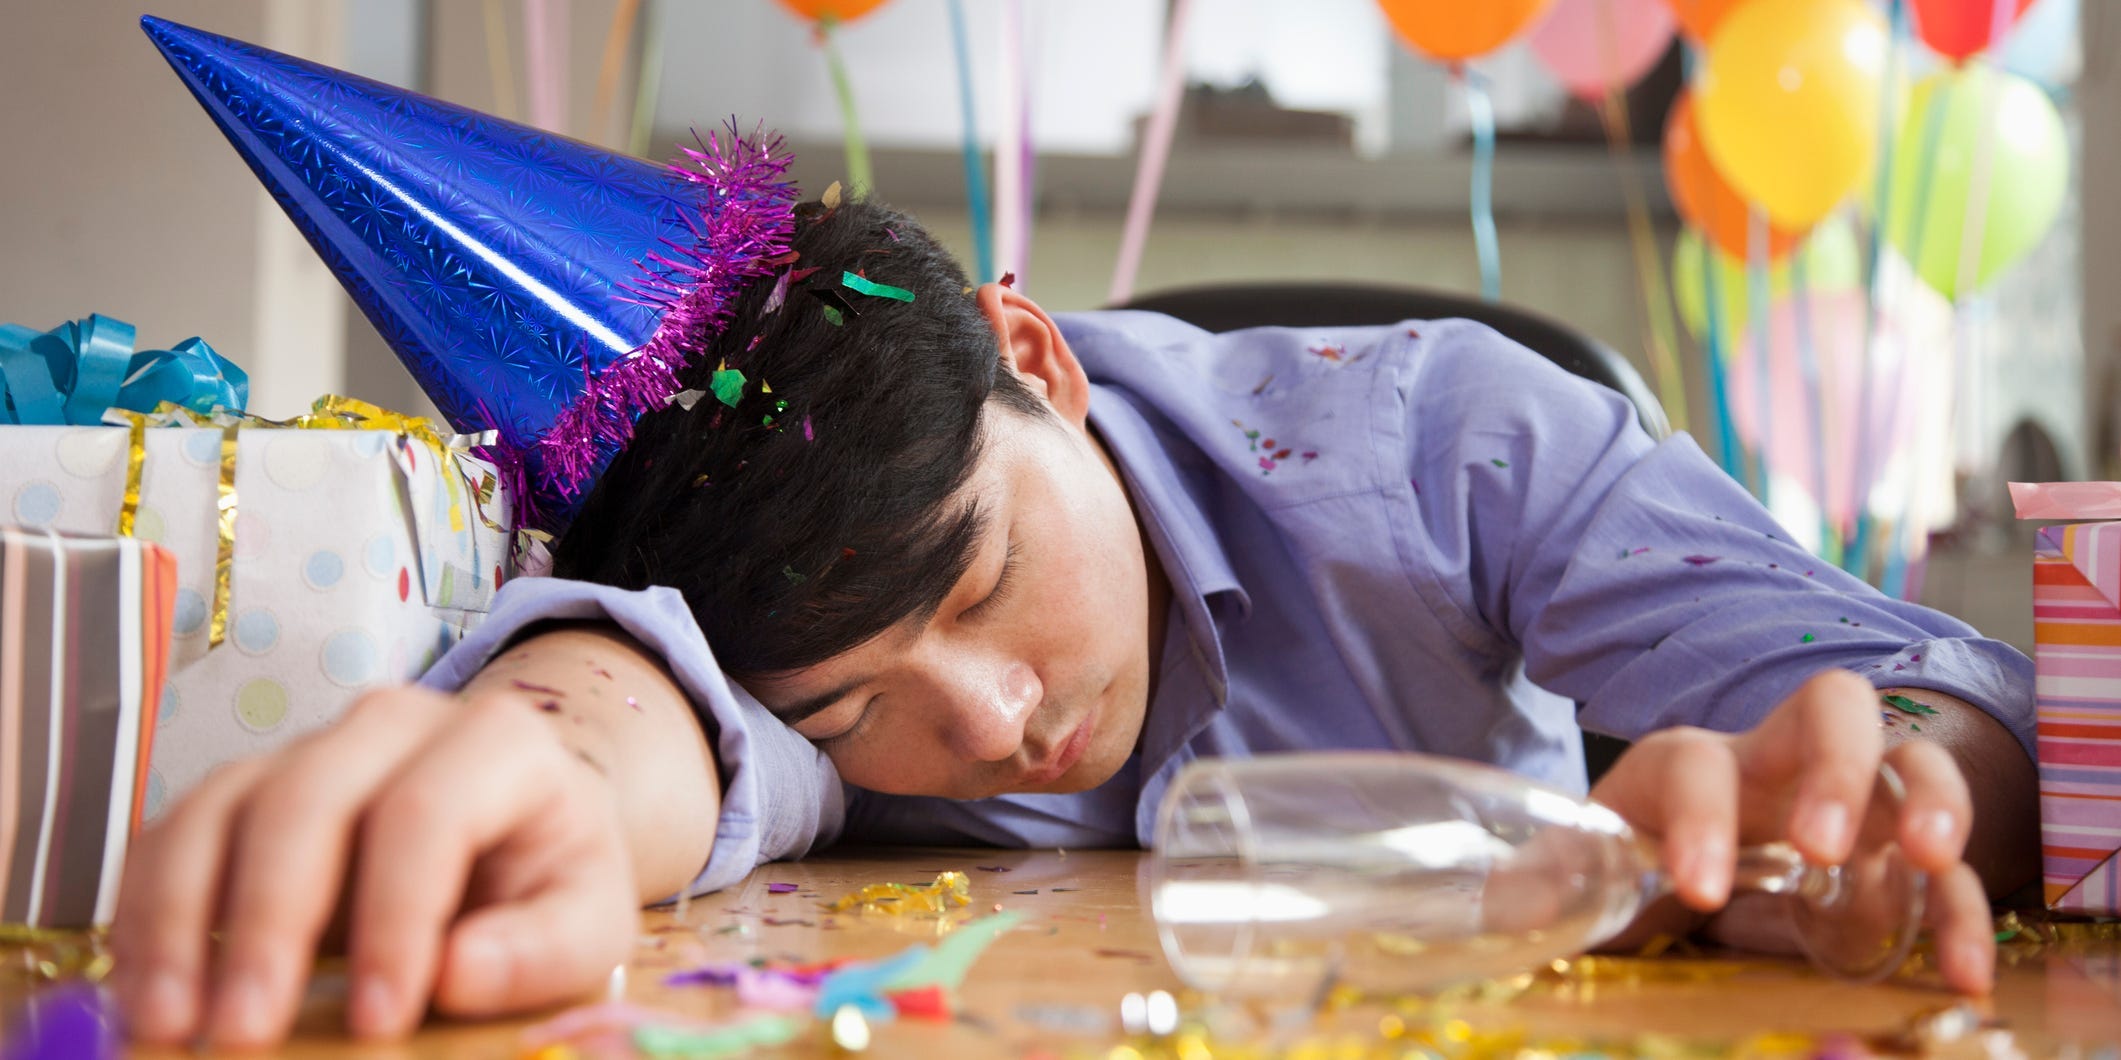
[1147,753,1926,996]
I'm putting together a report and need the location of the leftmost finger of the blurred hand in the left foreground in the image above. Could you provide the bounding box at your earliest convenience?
[110,759,265,1045]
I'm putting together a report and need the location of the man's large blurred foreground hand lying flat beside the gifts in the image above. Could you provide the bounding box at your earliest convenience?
[110,689,638,1047]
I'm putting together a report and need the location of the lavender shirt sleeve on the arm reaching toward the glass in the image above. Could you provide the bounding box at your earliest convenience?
[1408,322,2034,755]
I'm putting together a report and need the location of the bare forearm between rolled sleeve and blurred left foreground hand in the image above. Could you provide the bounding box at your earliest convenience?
[464,623,721,905]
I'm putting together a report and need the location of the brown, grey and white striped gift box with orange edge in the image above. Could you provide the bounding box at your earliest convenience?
[0,526,176,929]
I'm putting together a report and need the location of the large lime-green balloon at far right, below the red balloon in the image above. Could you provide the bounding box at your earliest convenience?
[1886,64,2070,299]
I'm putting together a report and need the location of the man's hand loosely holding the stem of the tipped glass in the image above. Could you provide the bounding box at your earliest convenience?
[1591,670,2030,994]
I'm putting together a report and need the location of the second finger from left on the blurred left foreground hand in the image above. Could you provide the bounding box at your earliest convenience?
[208,691,458,1047]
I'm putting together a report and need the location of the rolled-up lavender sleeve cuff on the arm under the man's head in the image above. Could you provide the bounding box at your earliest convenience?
[420,577,844,895]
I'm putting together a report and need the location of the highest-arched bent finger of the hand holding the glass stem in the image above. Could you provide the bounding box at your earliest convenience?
[1739,670,1886,865]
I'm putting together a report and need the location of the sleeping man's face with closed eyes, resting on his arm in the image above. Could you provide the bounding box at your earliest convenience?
[747,407,1169,799]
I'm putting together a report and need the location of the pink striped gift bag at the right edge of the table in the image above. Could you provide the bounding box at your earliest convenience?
[2011,481,2121,914]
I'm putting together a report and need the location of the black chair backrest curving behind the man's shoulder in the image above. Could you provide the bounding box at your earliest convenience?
[1114,284,1671,782]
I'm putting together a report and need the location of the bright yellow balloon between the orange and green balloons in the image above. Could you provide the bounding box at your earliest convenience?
[1695,0,1886,231]
